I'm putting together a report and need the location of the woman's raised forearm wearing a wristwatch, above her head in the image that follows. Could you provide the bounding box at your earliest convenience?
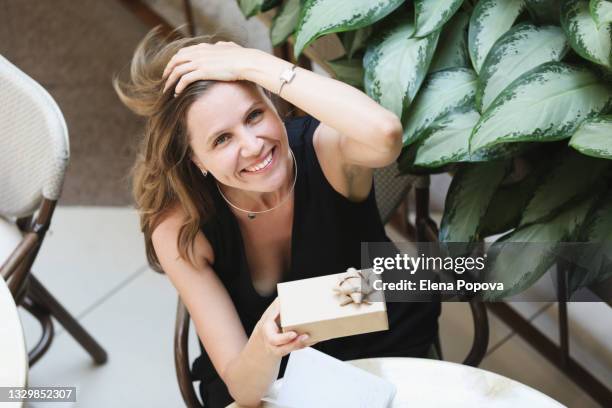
[243,49,401,149]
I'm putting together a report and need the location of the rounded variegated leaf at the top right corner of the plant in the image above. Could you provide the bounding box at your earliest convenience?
[561,0,612,67]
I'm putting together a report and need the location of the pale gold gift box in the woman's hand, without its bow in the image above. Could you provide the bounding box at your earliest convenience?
[277,268,389,342]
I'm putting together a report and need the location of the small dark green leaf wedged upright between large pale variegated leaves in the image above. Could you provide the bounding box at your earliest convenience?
[429,11,472,72]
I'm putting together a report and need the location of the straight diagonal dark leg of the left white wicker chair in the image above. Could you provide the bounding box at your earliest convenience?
[28,273,108,364]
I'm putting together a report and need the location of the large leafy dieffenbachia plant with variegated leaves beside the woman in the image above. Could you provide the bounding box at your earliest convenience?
[238,0,612,300]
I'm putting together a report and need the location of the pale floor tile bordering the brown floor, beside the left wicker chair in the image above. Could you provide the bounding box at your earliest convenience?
[21,207,146,342]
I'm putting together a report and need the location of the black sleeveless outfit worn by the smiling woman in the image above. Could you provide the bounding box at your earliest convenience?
[192,116,440,408]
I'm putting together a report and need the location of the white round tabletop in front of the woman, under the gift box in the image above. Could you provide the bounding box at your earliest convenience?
[227,357,564,408]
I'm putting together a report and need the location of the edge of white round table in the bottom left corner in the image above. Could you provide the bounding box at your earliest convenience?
[0,277,28,407]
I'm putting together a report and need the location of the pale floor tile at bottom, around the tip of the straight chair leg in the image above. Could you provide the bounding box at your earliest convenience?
[24,270,183,408]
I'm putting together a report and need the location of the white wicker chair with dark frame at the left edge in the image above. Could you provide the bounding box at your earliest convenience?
[0,56,107,367]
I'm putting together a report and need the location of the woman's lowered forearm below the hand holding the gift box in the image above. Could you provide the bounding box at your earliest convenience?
[223,326,281,407]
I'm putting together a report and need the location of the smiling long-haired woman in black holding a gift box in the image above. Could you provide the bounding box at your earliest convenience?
[114,26,440,407]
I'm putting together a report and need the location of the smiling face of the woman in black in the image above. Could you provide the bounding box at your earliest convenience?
[187,82,292,192]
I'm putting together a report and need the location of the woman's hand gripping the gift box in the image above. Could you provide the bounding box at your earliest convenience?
[255,297,316,357]
